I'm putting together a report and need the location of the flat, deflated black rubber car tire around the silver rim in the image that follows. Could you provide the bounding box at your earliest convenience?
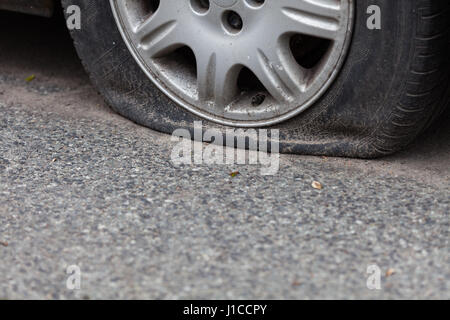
[62,0,450,158]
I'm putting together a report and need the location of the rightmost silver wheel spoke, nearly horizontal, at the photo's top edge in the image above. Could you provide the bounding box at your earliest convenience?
[278,0,342,40]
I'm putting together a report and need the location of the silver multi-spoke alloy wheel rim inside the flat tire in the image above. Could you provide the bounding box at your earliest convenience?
[110,0,354,127]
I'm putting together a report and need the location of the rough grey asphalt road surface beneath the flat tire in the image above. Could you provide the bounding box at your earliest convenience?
[0,13,450,299]
